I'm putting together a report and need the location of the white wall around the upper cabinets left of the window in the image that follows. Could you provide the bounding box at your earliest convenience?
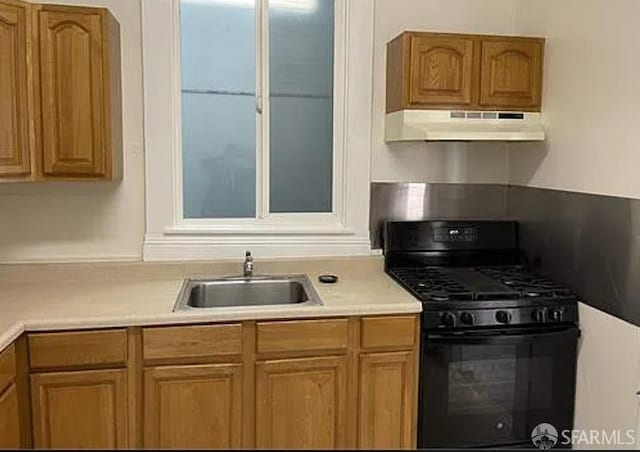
[0,0,144,262]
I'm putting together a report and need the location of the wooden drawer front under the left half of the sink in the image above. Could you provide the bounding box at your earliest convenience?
[142,323,242,360]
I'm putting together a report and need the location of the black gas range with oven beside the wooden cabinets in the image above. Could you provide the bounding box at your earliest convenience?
[384,221,579,447]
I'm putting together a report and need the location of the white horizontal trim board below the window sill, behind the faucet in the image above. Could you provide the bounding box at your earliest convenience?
[143,236,371,261]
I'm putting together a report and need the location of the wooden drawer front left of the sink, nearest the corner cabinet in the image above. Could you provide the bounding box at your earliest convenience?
[29,329,127,369]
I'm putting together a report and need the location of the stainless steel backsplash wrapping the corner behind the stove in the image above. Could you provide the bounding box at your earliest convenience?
[370,183,640,326]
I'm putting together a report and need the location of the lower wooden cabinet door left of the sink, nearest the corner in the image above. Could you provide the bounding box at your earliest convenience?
[31,370,127,449]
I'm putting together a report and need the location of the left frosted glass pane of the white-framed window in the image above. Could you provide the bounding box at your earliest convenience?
[181,0,256,218]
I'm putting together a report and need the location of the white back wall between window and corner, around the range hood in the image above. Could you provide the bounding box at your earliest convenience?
[372,0,515,183]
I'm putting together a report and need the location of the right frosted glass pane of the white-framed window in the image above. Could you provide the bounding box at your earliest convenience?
[269,0,333,213]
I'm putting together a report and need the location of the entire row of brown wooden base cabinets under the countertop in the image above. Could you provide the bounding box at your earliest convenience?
[17,315,419,450]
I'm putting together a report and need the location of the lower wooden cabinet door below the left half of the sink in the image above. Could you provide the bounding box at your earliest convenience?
[144,364,242,449]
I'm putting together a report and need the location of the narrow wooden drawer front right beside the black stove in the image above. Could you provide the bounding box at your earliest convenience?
[361,316,416,348]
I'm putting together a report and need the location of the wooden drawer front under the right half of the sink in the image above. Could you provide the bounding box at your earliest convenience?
[257,319,349,353]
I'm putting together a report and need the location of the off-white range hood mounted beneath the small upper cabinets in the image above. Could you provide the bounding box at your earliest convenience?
[385,110,545,142]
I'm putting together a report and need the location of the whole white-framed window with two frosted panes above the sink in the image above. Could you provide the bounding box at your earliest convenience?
[143,0,373,260]
